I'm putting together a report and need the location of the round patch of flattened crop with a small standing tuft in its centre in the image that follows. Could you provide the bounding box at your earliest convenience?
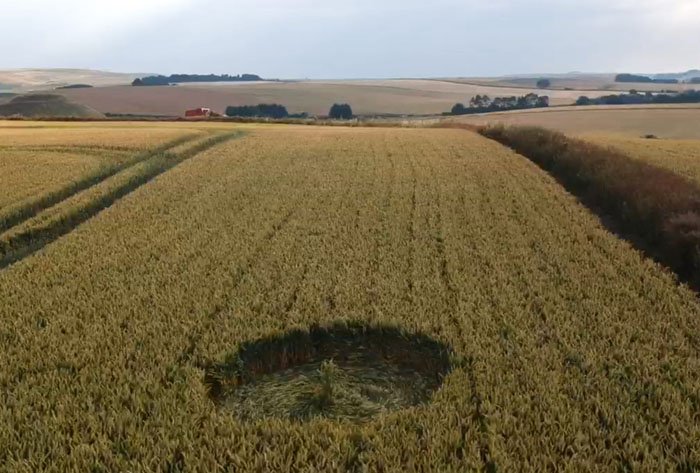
[206,324,451,422]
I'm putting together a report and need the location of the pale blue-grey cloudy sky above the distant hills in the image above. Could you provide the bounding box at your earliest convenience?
[0,0,700,78]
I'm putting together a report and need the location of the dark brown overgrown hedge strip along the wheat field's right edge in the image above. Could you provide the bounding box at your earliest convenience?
[478,125,700,290]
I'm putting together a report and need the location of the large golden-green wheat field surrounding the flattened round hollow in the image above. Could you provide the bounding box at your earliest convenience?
[0,124,700,472]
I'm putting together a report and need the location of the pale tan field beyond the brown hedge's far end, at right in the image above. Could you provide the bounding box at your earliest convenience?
[447,105,700,139]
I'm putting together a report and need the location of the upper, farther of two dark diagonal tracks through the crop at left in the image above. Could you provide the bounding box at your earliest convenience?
[0,134,198,233]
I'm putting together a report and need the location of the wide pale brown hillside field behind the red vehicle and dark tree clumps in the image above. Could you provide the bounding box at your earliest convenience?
[60,79,603,116]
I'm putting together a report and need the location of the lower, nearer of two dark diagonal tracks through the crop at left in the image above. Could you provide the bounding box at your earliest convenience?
[0,130,244,270]
